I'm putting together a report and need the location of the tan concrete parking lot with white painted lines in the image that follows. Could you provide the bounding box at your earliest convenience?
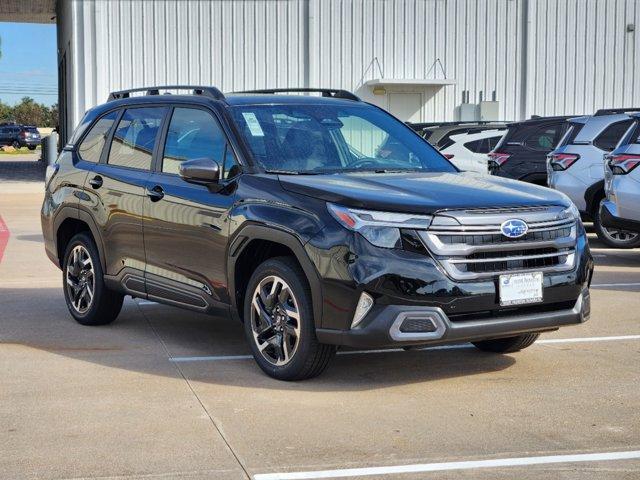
[0,158,640,480]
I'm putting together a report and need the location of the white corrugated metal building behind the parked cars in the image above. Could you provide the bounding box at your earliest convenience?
[0,0,640,142]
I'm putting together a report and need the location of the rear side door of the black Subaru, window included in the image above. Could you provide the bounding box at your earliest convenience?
[87,106,167,294]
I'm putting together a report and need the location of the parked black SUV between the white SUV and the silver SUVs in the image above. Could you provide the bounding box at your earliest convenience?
[489,117,571,186]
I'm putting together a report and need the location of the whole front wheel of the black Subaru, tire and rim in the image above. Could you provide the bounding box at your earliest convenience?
[244,257,336,380]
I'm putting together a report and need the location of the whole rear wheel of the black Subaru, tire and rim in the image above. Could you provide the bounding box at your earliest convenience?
[62,232,124,326]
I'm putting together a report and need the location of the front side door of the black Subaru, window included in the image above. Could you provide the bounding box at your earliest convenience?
[144,107,238,311]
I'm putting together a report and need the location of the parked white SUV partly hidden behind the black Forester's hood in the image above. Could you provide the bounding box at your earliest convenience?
[440,128,507,174]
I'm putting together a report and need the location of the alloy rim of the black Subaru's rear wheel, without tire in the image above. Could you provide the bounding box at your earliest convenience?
[65,245,96,314]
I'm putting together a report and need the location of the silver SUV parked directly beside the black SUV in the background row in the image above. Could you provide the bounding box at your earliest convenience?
[547,109,640,248]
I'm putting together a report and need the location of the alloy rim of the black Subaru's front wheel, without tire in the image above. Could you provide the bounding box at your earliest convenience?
[251,275,301,366]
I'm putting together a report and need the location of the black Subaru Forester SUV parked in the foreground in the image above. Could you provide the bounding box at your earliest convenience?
[42,86,593,380]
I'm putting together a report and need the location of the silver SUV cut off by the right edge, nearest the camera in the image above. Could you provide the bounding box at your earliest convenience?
[600,114,640,240]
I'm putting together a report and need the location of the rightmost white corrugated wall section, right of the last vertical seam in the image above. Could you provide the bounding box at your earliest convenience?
[527,0,640,115]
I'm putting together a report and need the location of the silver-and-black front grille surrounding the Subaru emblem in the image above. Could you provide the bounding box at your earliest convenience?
[420,207,577,280]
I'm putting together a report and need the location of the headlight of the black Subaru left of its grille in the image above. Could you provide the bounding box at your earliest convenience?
[327,203,433,248]
